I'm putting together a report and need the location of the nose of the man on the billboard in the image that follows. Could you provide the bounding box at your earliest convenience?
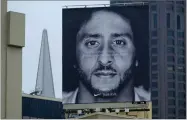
[98,48,113,66]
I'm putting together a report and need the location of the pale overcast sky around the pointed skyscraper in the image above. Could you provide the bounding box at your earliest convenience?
[8,0,109,98]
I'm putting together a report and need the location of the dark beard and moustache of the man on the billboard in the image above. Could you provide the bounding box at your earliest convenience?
[79,64,134,98]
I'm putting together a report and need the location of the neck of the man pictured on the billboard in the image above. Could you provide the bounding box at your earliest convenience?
[77,80,134,103]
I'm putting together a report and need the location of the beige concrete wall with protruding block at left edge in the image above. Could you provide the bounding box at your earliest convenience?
[1,0,25,119]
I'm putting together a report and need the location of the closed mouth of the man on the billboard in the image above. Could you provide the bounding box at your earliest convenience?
[94,70,117,77]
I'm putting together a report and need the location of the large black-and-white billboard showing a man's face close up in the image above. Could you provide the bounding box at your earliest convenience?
[62,5,151,104]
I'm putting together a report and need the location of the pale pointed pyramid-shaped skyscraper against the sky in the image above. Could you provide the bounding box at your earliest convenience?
[35,29,55,98]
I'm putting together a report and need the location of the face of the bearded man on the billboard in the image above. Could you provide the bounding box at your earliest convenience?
[76,11,135,96]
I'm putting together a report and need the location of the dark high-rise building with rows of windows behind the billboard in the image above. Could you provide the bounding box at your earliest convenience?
[110,0,186,119]
